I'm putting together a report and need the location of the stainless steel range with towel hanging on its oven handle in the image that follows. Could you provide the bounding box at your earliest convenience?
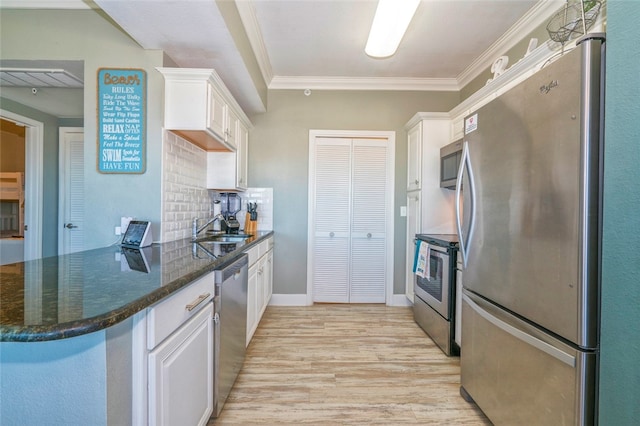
[413,234,460,356]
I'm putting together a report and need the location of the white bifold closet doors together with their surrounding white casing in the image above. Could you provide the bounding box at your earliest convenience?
[307,130,395,304]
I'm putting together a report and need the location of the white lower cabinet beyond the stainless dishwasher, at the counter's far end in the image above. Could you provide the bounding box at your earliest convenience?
[247,237,273,346]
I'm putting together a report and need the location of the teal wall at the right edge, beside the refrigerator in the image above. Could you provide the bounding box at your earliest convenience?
[599,0,640,426]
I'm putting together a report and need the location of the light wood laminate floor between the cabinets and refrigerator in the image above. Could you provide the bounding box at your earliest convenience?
[209,304,491,425]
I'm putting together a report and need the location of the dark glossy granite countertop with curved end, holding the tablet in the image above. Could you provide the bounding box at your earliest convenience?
[0,231,273,342]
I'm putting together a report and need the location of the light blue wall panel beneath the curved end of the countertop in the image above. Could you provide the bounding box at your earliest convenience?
[0,331,107,426]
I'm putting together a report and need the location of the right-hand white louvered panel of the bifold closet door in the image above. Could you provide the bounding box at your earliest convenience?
[349,139,391,303]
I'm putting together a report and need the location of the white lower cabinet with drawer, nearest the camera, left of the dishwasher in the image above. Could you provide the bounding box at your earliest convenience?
[147,274,214,426]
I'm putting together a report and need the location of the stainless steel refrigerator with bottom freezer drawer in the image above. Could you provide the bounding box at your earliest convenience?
[456,34,604,425]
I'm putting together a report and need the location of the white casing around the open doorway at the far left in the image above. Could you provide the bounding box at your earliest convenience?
[0,109,44,260]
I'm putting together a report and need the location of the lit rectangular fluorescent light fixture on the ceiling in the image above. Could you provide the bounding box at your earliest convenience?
[364,0,420,58]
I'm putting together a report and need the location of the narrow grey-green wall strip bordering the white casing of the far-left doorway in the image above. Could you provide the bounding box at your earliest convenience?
[0,96,58,257]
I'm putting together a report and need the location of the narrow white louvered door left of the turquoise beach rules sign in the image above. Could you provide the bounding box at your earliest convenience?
[58,127,84,254]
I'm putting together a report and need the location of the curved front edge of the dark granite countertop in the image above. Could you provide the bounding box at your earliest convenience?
[0,231,273,343]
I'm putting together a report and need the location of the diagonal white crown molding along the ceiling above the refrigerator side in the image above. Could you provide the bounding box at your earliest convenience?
[457,0,565,88]
